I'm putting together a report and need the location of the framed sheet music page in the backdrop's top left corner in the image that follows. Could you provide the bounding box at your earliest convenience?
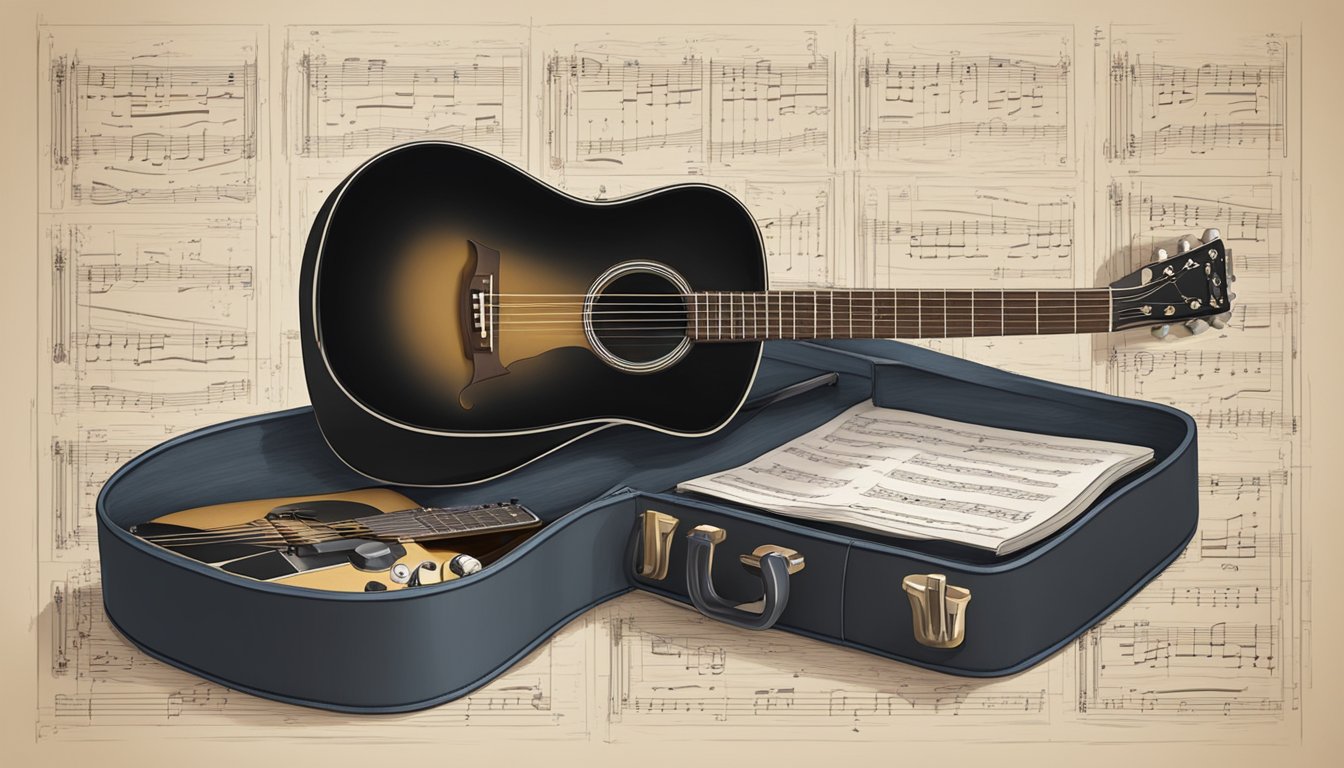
[47,28,261,208]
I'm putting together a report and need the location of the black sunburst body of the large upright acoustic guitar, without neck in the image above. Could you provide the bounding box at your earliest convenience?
[301,141,766,484]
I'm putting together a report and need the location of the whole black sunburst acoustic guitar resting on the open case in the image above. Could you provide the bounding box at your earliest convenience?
[301,141,1232,484]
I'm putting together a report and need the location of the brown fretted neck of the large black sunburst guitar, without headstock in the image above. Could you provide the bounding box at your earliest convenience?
[688,288,1113,342]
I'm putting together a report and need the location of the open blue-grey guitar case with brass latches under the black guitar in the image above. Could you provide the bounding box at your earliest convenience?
[97,186,1198,713]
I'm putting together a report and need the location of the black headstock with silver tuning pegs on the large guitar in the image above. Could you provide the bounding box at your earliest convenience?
[1110,229,1236,339]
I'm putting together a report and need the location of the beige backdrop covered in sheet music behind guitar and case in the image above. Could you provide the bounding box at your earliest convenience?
[15,4,1310,746]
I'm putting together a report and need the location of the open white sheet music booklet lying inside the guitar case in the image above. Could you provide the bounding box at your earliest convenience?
[677,402,1153,554]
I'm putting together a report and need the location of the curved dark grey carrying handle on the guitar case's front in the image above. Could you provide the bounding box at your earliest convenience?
[685,525,805,629]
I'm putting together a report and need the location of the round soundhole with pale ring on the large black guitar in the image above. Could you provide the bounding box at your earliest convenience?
[585,262,689,373]
